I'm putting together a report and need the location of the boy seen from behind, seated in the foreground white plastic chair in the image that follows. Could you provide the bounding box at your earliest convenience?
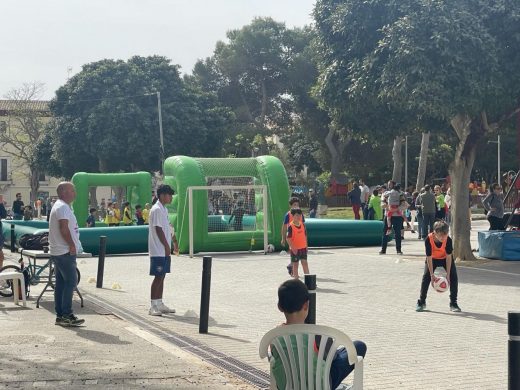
[271,279,367,389]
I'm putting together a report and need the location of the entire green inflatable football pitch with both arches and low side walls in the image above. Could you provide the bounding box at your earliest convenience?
[2,156,383,255]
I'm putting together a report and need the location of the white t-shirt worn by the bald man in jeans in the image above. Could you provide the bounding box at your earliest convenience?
[49,199,83,256]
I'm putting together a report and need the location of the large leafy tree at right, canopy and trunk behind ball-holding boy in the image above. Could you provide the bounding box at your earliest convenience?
[315,0,520,260]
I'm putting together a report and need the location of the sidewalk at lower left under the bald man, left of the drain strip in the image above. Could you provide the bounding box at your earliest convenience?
[0,278,253,390]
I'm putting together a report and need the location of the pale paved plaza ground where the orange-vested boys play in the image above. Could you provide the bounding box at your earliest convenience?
[0,223,520,389]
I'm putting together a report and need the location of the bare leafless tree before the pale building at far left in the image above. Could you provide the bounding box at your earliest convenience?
[0,82,49,202]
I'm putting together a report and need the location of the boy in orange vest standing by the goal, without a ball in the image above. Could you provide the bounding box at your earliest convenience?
[287,209,309,279]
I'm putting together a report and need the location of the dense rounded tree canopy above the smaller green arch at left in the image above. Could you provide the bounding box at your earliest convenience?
[38,56,232,177]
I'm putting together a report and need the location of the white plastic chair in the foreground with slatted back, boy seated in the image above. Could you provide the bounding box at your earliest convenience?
[259,325,363,390]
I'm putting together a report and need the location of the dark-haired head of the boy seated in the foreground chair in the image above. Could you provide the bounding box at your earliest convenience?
[278,279,309,325]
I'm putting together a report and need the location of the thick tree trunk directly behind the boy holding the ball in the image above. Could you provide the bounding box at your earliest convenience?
[449,115,485,260]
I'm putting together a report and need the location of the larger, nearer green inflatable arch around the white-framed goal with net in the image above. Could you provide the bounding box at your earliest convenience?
[164,156,290,253]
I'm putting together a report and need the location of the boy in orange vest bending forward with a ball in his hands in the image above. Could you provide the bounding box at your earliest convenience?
[415,221,460,312]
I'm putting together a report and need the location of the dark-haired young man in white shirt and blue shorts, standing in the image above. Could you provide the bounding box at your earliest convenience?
[148,184,178,316]
